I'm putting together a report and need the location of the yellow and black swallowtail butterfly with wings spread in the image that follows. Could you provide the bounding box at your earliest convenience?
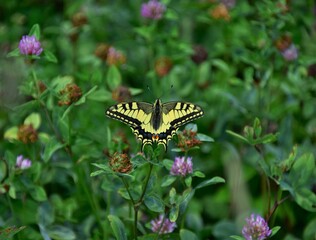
[105,99,204,151]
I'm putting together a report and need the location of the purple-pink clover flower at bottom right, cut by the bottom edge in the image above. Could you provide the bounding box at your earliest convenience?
[242,214,272,240]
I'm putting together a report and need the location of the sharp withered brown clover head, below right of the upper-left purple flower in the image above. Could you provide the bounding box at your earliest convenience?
[58,83,82,106]
